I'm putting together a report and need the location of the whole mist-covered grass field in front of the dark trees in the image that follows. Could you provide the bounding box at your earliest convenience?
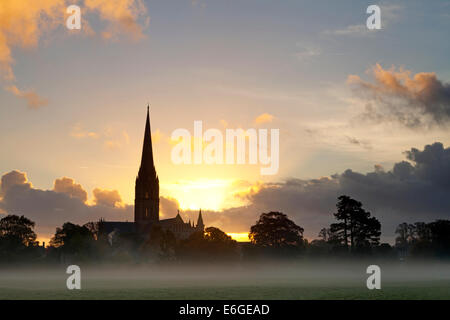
[0,264,450,300]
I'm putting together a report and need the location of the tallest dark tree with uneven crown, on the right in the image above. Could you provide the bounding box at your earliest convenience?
[330,195,381,251]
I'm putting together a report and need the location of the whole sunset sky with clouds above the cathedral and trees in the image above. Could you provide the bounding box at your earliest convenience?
[0,0,450,242]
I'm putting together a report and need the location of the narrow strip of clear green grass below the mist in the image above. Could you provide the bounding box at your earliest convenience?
[0,281,450,300]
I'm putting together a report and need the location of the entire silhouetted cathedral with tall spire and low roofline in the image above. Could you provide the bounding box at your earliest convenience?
[99,107,205,239]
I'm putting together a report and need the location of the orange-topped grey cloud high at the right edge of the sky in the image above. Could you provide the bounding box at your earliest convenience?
[347,64,450,128]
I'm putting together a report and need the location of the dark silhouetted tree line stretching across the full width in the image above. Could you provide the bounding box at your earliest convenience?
[0,195,450,263]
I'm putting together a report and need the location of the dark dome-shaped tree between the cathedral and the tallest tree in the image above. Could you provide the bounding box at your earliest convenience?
[249,211,304,248]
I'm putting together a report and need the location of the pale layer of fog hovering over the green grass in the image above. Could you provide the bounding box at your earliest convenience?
[0,261,450,290]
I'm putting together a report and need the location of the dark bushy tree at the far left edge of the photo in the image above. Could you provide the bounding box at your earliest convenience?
[0,215,36,249]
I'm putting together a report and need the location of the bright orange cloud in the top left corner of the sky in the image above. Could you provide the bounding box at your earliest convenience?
[0,0,149,109]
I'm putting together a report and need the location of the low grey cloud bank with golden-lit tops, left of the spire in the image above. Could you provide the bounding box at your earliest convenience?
[0,170,133,236]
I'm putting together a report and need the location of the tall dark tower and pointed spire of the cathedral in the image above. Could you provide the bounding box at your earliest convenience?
[134,107,159,230]
